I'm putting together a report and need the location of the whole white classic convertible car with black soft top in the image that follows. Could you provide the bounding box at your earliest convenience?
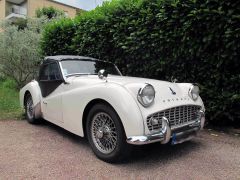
[20,56,205,162]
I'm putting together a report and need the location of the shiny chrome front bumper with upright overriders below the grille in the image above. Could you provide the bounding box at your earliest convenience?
[127,111,205,145]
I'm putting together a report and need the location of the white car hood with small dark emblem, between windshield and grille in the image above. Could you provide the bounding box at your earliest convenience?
[70,75,195,101]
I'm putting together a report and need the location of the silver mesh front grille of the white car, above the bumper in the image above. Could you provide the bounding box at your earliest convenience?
[147,105,201,131]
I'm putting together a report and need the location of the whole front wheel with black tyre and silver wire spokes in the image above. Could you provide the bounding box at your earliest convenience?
[86,104,131,162]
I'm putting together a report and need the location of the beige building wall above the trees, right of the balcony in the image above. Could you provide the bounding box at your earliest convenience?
[28,0,77,17]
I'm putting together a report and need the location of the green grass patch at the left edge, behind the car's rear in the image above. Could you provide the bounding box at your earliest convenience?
[0,80,23,120]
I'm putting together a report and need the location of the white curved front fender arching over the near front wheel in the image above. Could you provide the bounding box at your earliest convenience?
[62,82,144,137]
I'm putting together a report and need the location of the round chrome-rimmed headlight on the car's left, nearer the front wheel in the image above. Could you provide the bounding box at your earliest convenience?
[137,84,155,107]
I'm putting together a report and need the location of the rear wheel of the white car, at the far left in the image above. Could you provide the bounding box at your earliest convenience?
[25,94,39,124]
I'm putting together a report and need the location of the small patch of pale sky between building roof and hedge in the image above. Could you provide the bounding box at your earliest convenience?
[55,0,104,10]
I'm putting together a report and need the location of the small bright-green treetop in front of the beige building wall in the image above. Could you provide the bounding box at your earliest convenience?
[35,6,65,19]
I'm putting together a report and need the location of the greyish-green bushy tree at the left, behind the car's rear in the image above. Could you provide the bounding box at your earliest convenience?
[0,19,46,88]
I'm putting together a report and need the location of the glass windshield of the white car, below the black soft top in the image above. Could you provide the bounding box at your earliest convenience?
[61,60,121,76]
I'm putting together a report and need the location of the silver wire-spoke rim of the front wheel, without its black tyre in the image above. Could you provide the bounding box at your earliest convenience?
[91,112,118,154]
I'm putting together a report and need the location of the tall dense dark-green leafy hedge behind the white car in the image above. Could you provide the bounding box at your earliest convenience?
[42,0,240,124]
